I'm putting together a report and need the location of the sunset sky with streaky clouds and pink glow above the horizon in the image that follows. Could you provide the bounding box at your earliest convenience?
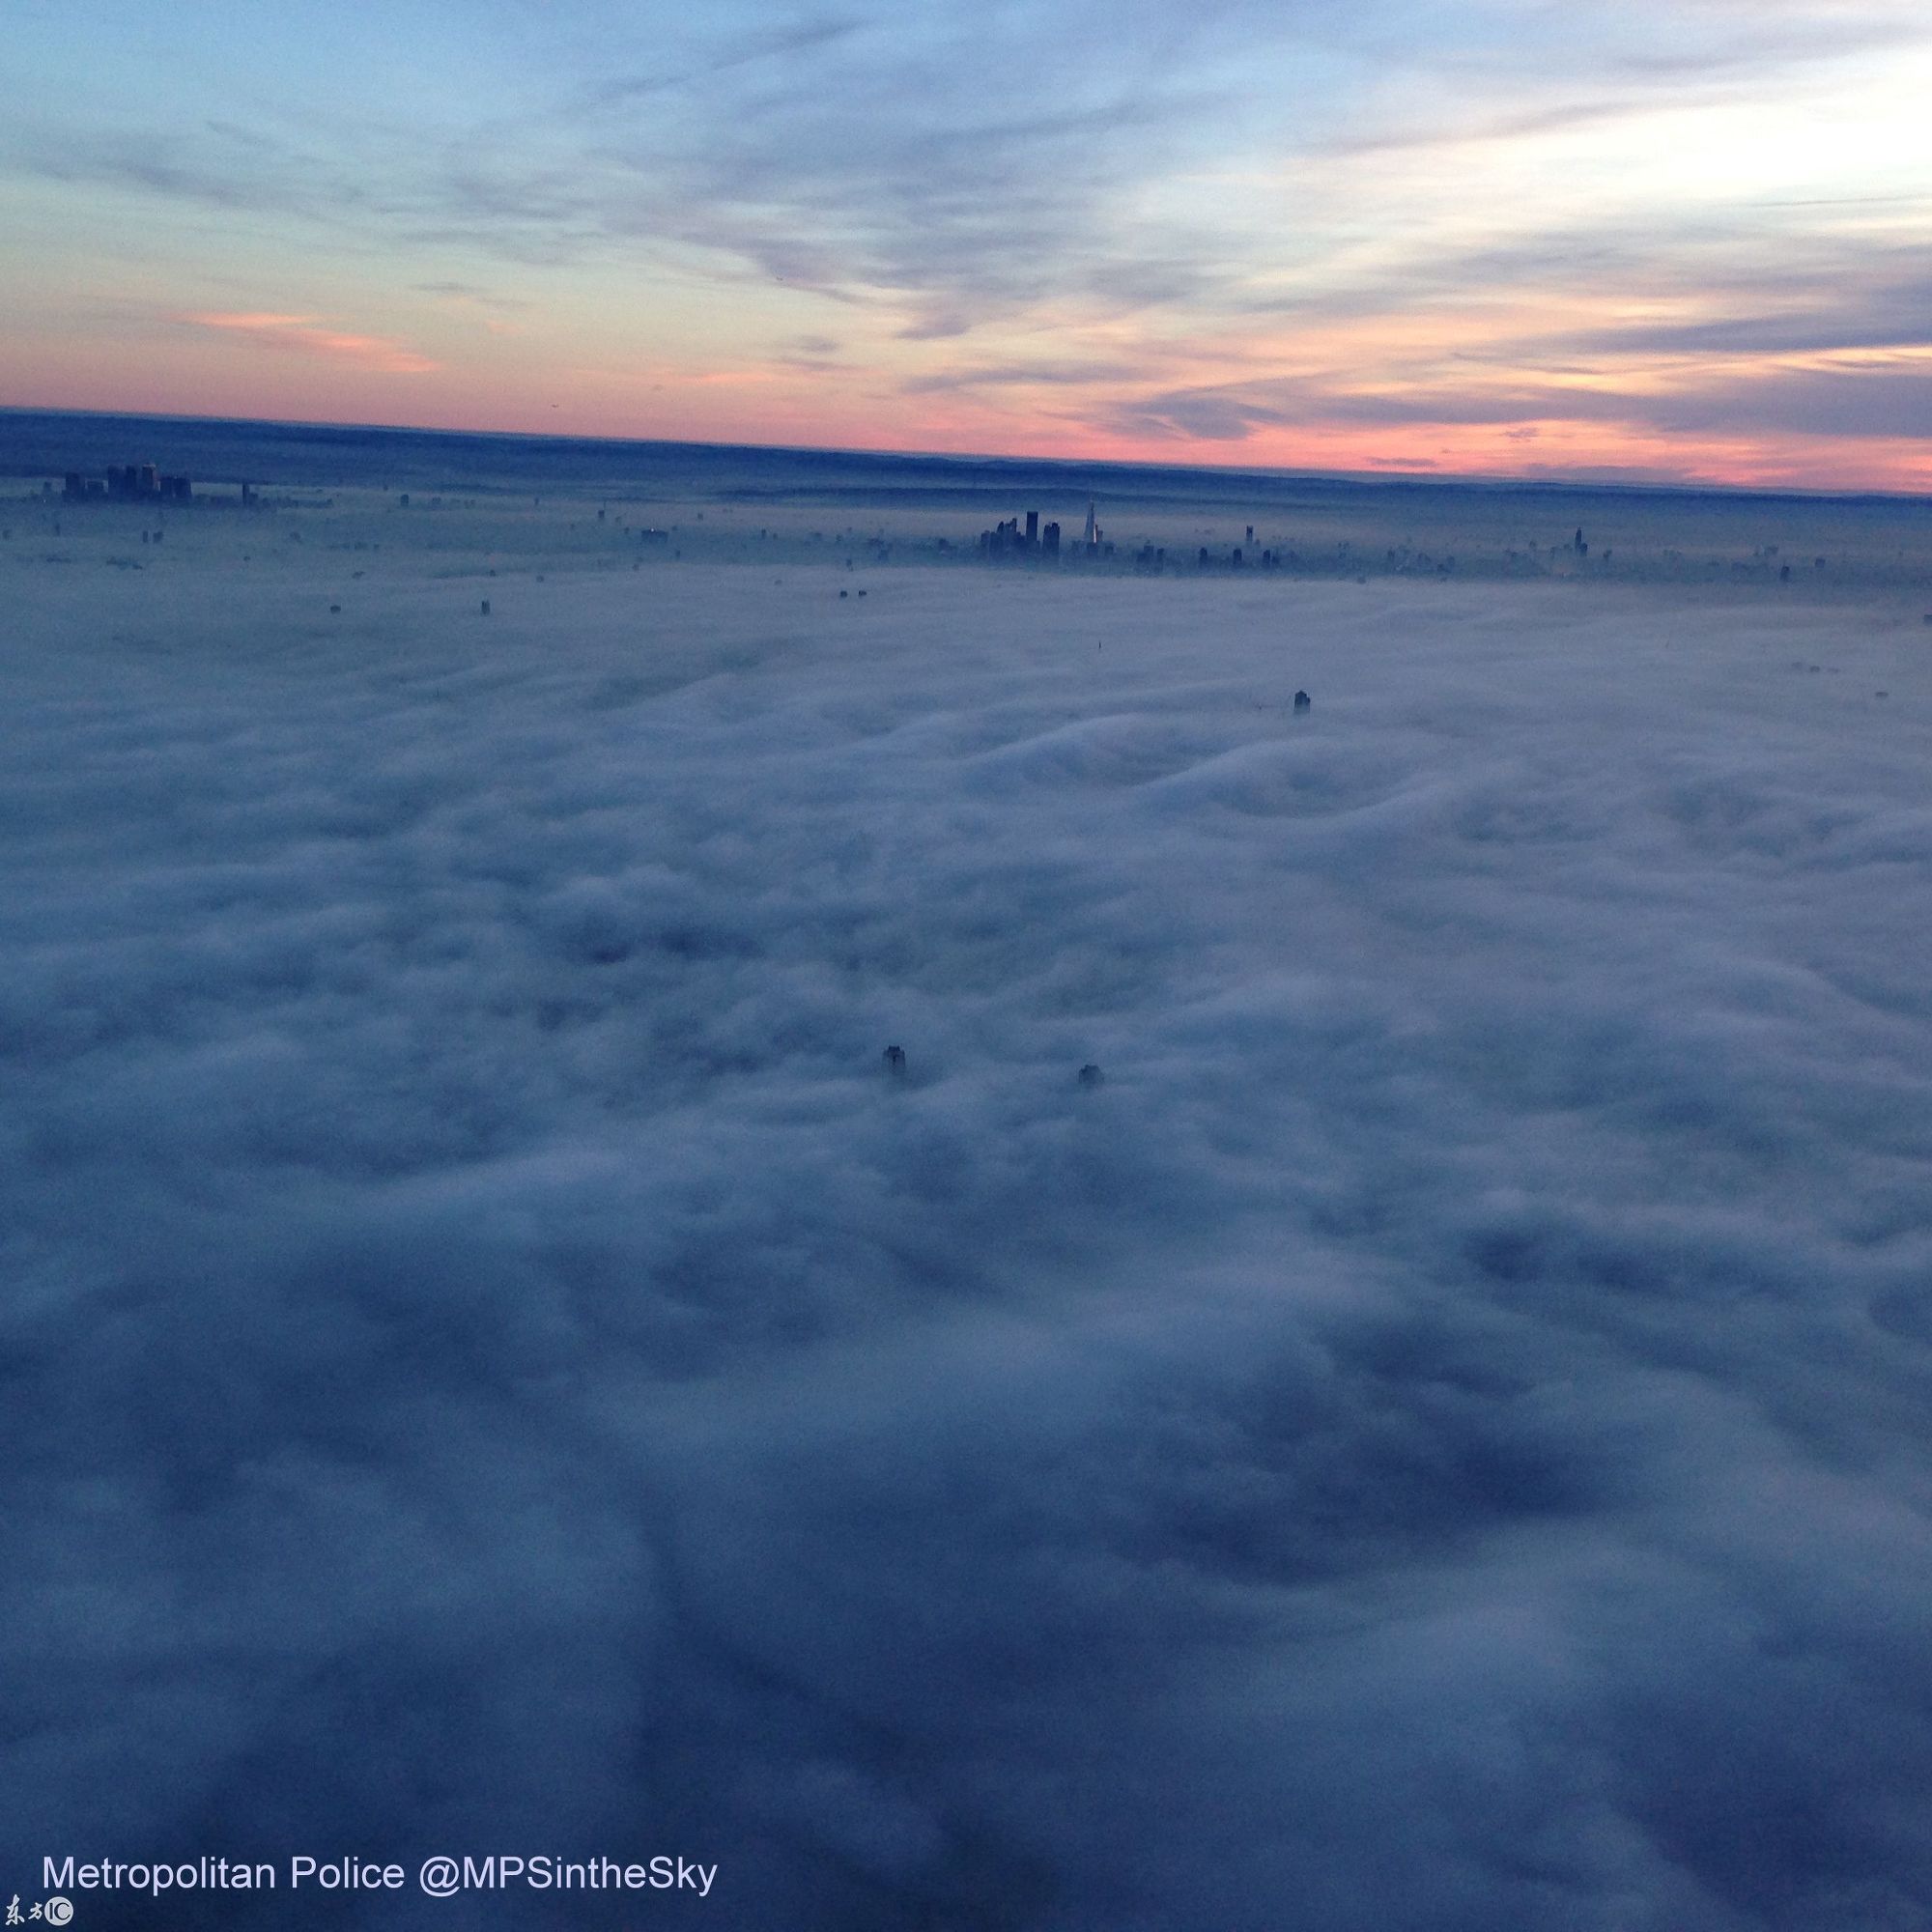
[0,0,1932,489]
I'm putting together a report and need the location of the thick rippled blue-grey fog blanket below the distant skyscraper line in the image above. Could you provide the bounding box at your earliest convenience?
[0,522,1932,1932]
